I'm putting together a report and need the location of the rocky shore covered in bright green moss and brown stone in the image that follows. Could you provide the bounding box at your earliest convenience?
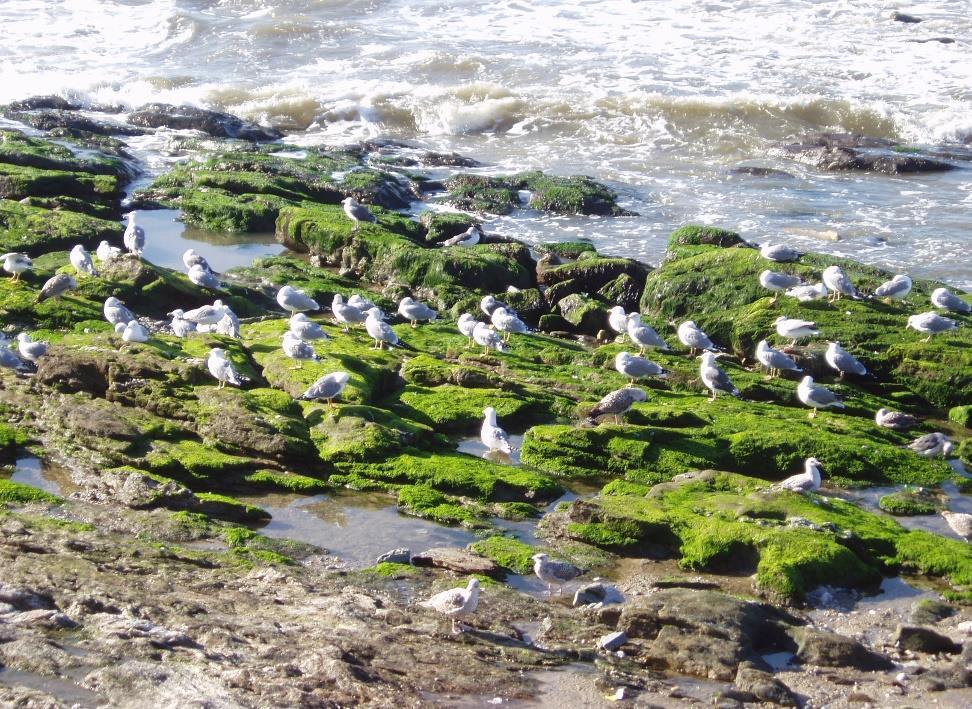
[0,97,972,707]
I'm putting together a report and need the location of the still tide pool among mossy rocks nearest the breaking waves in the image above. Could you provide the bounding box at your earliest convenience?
[127,209,285,272]
